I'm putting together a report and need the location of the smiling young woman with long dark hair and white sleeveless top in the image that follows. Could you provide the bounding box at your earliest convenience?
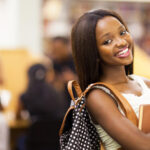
[72,10,150,150]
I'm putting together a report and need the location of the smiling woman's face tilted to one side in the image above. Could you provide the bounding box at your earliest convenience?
[96,16,133,66]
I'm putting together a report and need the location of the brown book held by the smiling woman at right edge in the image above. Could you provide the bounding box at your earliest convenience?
[138,104,150,133]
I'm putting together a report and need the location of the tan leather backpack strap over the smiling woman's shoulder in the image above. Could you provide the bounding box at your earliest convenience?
[82,82,138,126]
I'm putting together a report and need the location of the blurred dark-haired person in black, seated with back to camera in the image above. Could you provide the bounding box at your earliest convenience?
[17,64,64,150]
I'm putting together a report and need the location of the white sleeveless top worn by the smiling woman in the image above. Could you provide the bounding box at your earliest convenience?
[93,75,150,150]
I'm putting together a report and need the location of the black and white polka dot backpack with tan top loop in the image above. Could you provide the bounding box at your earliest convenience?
[59,81,100,150]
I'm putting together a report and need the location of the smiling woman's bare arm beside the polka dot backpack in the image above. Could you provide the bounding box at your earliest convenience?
[86,89,150,150]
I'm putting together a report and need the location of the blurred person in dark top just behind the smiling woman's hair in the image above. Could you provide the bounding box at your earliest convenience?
[45,36,77,109]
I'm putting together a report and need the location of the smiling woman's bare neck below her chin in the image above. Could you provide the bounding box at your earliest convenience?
[100,66,129,85]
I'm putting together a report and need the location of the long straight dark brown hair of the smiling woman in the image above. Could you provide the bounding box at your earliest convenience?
[71,9,133,90]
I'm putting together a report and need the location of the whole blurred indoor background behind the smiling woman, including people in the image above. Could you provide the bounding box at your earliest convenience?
[0,0,150,150]
